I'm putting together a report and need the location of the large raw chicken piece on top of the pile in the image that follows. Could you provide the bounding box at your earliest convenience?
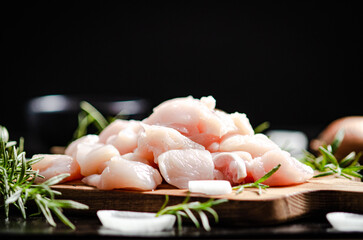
[143,96,253,147]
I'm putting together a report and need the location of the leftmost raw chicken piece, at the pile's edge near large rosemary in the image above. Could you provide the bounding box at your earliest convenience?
[32,154,82,183]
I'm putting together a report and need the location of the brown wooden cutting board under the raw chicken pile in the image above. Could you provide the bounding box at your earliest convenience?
[53,176,363,225]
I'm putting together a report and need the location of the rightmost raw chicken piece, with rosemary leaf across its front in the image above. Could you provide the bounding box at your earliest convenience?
[247,149,314,186]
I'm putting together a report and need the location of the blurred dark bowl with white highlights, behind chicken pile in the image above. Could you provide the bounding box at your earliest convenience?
[26,95,151,153]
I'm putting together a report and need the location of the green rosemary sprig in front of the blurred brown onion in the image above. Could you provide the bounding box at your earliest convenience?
[300,130,363,179]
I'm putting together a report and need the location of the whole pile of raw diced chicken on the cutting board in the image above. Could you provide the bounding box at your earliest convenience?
[33,96,313,190]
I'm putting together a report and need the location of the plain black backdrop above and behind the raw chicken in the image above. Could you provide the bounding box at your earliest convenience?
[0,1,362,141]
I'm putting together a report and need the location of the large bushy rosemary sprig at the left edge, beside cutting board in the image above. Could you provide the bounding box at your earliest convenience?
[0,126,88,229]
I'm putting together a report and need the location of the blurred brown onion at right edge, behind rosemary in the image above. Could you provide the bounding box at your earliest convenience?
[310,116,363,159]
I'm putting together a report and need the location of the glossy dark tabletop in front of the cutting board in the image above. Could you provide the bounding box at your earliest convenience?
[0,215,363,239]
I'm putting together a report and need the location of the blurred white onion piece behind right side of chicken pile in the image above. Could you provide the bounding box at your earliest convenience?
[266,130,308,158]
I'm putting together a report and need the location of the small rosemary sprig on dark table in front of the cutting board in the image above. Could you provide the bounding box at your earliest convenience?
[156,194,228,231]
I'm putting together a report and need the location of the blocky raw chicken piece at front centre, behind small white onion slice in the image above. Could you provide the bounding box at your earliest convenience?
[158,149,214,188]
